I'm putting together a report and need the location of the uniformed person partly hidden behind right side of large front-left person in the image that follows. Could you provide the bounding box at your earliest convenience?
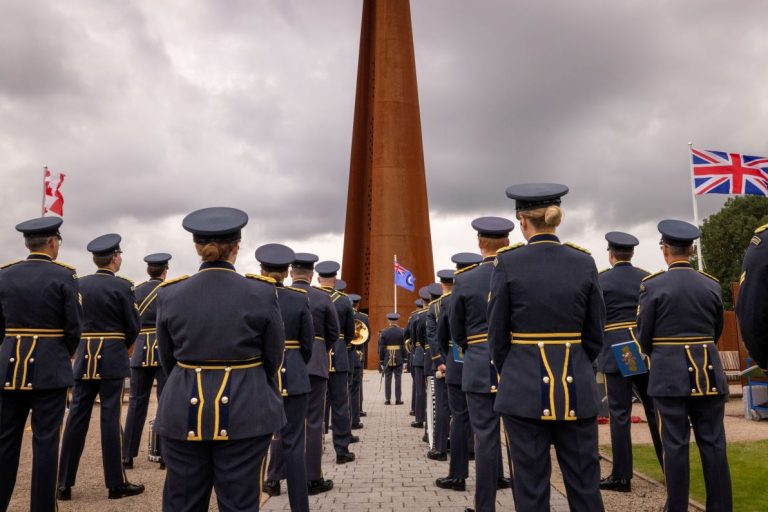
[256,244,315,512]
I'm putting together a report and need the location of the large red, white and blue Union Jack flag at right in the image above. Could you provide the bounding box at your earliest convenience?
[691,148,768,196]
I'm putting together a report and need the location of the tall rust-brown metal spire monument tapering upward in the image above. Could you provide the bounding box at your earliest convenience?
[342,0,434,368]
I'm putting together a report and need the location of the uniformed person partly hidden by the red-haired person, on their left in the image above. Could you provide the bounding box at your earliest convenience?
[435,253,480,491]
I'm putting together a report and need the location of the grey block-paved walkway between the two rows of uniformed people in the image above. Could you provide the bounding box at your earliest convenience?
[263,371,568,512]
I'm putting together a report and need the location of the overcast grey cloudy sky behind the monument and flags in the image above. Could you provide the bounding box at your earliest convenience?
[0,0,768,284]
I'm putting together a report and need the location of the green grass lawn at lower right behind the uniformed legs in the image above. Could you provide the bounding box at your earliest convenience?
[601,441,768,512]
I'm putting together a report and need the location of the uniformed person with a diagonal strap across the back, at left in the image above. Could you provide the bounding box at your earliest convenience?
[123,252,171,469]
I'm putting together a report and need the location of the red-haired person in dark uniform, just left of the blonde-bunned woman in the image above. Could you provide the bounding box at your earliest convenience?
[450,217,515,512]
